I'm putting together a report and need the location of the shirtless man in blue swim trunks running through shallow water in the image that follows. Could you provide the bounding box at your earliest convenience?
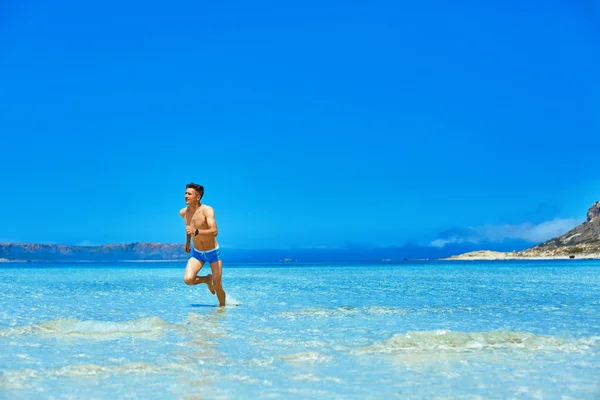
[179,183,225,307]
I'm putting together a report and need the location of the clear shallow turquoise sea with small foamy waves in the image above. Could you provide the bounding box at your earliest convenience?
[0,260,600,399]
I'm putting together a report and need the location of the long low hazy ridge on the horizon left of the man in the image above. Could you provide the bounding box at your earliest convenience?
[0,243,189,261]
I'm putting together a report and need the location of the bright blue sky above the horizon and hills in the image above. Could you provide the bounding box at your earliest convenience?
[0,0,600,248]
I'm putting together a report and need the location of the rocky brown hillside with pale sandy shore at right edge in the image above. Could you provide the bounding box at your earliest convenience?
[442,201,600,260]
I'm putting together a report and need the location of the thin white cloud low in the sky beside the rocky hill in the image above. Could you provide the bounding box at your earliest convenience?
[430,218,583,247]
